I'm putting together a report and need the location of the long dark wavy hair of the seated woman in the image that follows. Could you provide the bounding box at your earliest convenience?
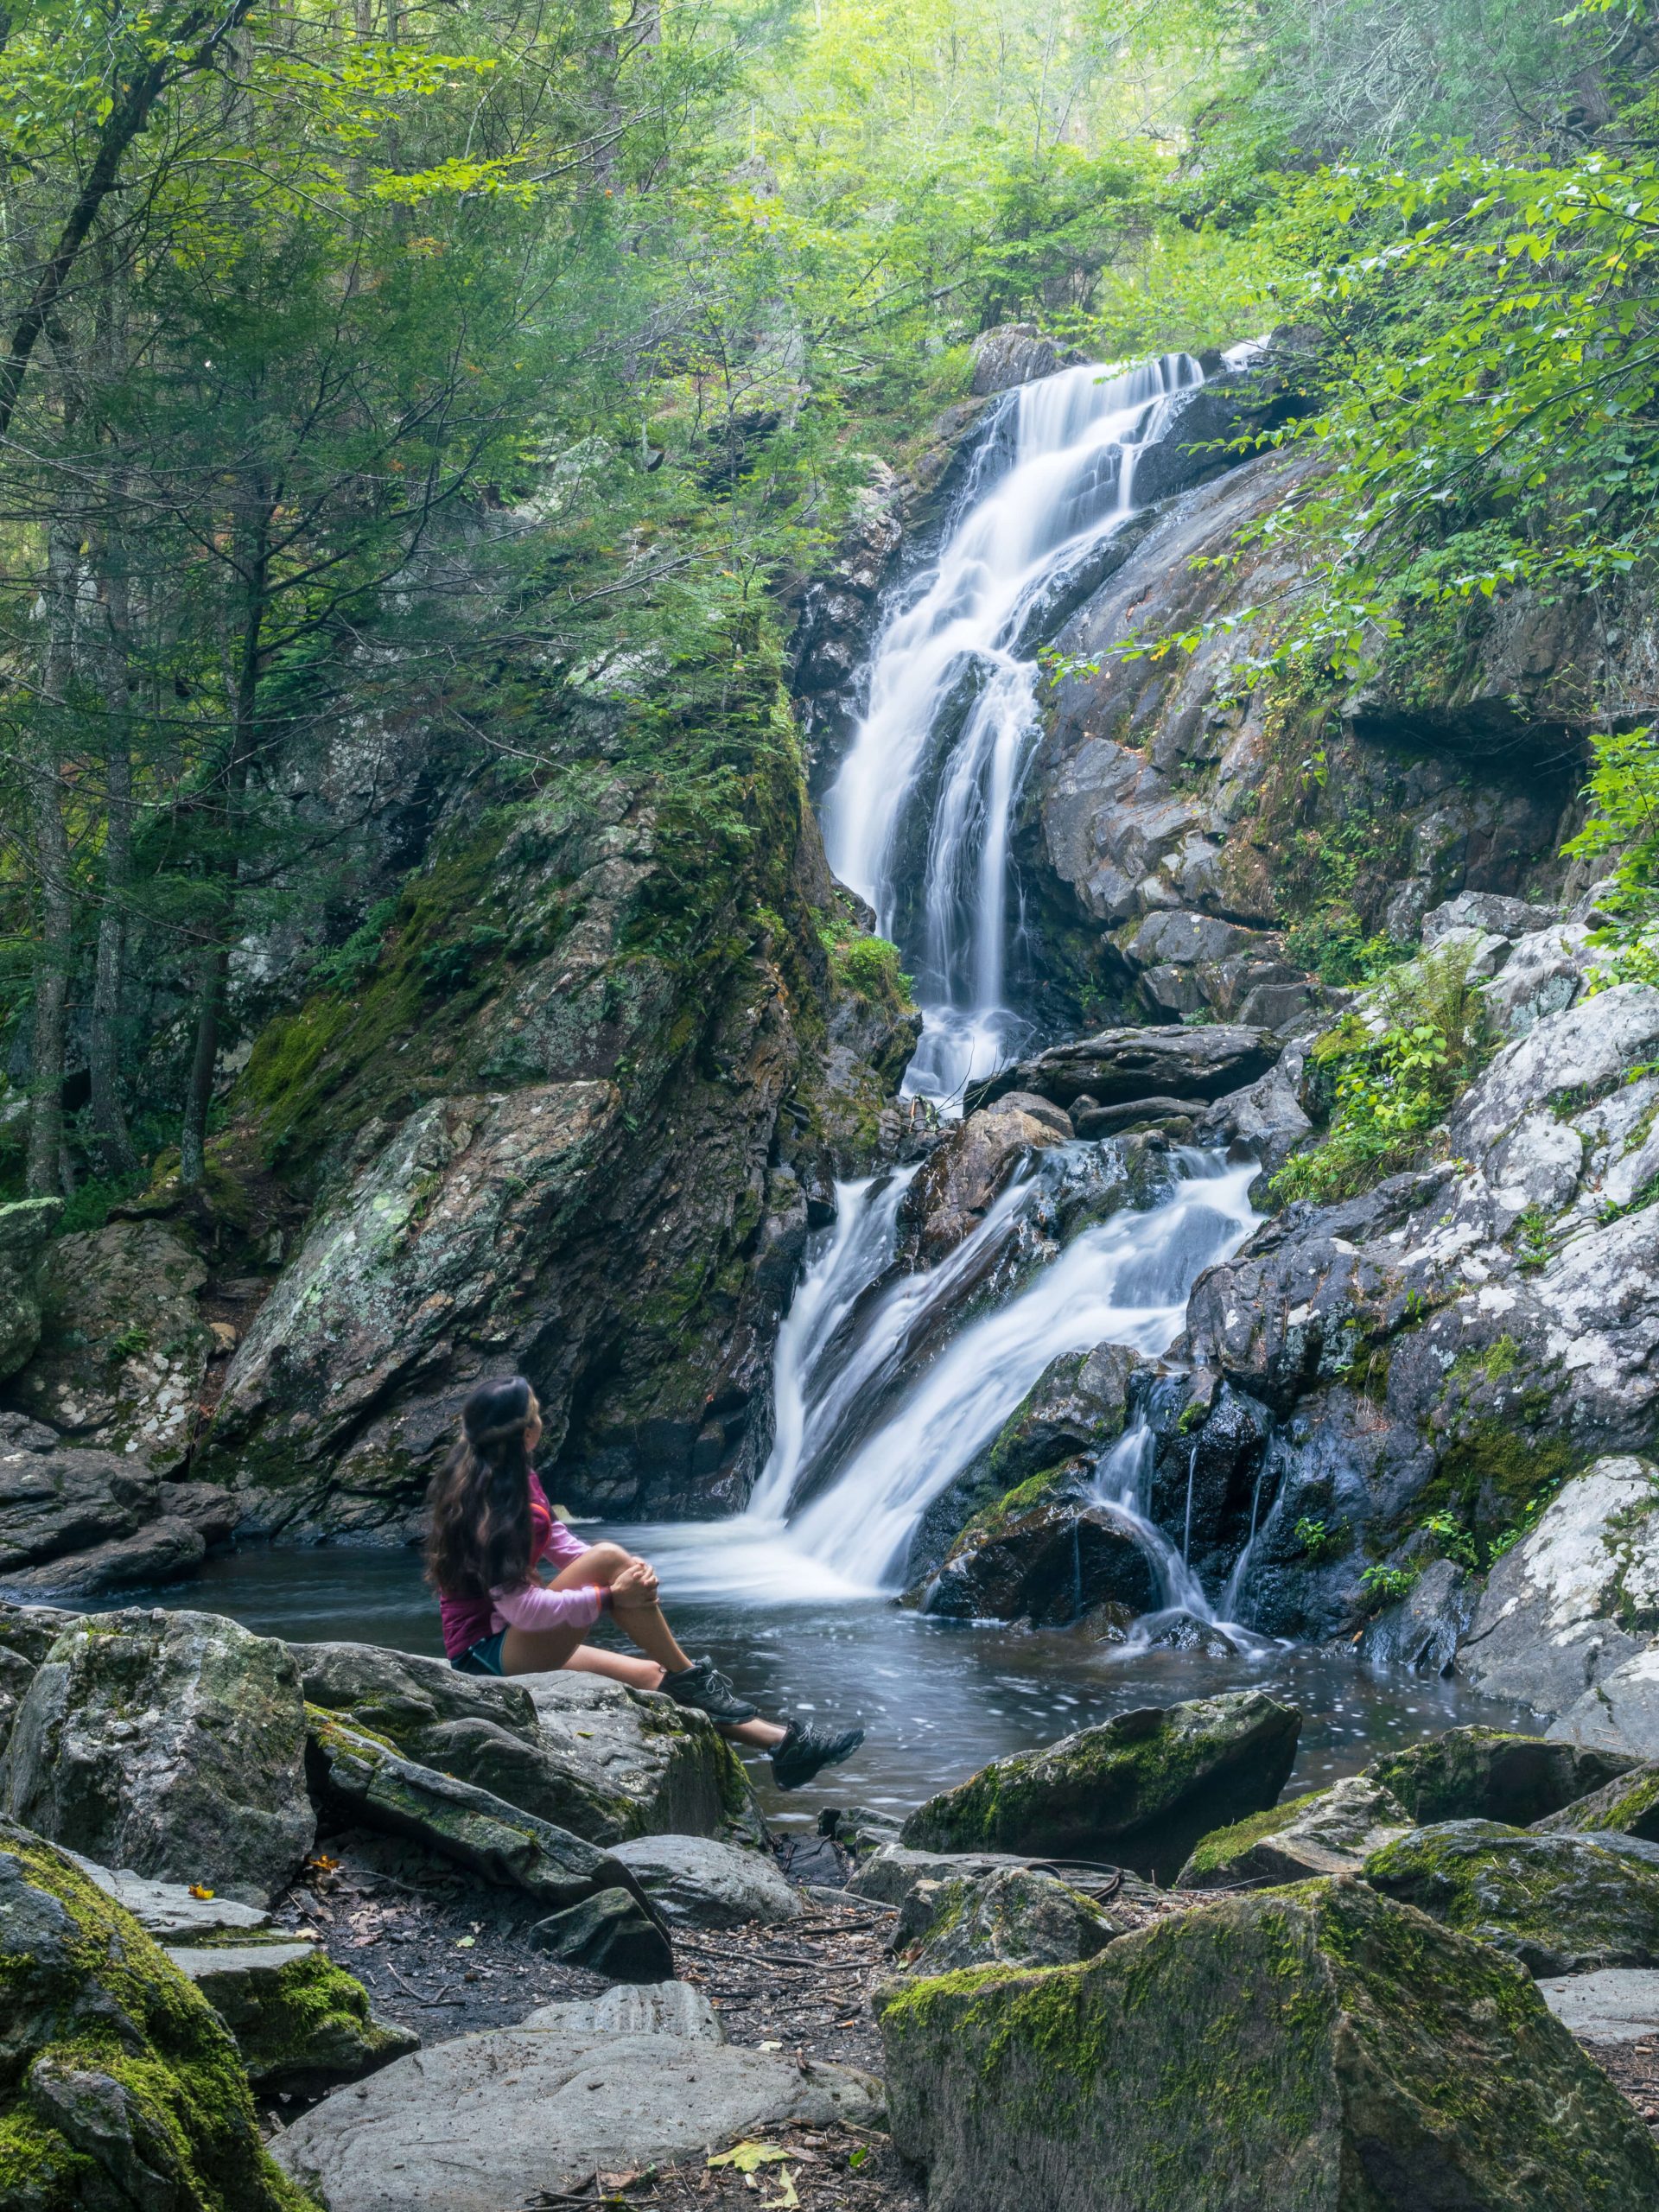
[427,1376,536,1597]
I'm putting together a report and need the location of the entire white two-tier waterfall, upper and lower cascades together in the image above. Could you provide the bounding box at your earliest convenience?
[651,354,1256,1619]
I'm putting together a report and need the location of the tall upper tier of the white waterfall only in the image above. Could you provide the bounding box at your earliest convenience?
[823,354,1204,1099]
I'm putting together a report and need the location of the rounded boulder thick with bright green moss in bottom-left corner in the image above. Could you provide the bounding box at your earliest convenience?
[0,1822,315,2212]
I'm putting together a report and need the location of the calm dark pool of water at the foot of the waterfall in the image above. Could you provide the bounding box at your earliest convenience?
[97,1524,1540,1827]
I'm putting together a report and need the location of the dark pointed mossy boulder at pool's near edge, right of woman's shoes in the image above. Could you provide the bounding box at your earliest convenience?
[902,1690,1303,1880]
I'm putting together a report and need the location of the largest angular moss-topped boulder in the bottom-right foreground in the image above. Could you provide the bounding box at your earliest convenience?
[878,1878,1659,2212]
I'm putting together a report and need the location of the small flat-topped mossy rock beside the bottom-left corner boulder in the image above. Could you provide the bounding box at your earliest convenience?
[168,1942,420,2097]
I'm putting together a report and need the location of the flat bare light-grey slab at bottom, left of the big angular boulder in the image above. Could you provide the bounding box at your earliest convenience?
[270,2006,885,2212]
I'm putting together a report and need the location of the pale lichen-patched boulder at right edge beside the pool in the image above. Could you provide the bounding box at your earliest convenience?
[1458,1458,1659,1719]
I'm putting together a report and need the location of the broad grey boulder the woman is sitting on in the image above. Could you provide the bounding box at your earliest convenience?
[294,1643,759,1845]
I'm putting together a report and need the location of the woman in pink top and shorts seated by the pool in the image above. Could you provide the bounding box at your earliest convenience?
[427,1376,865,1789]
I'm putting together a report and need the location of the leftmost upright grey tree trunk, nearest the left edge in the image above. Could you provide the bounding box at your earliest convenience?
[24,522,78,1199]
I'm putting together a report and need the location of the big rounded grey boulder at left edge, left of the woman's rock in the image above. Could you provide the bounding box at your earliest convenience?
[4,1611,316,1904]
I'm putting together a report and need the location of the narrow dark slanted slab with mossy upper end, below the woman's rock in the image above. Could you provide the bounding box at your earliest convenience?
[308,1707,641,1909]
